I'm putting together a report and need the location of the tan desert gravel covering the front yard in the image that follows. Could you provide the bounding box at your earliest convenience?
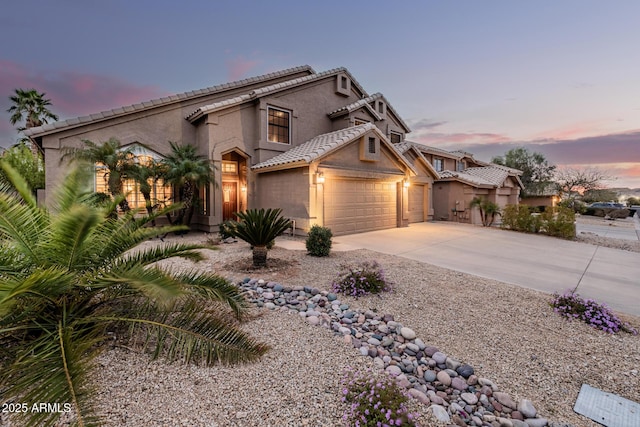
[0,219,640,427]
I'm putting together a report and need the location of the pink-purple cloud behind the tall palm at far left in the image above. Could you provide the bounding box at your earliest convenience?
[0,60,168,120]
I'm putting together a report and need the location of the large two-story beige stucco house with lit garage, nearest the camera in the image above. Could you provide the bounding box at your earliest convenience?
[26,66,439,235]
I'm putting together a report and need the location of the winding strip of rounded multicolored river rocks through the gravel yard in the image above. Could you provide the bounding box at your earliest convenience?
[237,278,572,427]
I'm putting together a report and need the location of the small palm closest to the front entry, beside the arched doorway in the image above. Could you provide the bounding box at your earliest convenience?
[162,141,215,226]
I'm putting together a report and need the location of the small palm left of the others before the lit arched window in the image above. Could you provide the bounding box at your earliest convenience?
[62,138,136,212]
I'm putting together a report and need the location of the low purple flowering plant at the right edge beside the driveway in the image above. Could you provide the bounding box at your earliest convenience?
[551,290,638,335]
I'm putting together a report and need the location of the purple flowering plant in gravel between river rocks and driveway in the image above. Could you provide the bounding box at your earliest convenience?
[331,261,391,298]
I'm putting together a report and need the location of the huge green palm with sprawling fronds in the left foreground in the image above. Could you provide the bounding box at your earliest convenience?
[0,161,267,426]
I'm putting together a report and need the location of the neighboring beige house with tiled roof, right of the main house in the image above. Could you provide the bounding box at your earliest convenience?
[404,142,523,224]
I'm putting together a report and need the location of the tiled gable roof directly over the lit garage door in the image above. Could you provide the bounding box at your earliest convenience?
[251,123,415,173]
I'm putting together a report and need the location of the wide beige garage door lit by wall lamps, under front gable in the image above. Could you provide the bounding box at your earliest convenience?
[324,179,397,235]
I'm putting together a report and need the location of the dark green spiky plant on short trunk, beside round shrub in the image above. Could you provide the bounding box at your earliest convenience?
[231,209,291,267]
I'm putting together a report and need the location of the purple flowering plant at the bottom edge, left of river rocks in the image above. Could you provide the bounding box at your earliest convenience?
[342,369,419,427]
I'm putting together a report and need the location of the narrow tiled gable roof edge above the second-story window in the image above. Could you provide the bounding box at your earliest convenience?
[185,67,370,123]
